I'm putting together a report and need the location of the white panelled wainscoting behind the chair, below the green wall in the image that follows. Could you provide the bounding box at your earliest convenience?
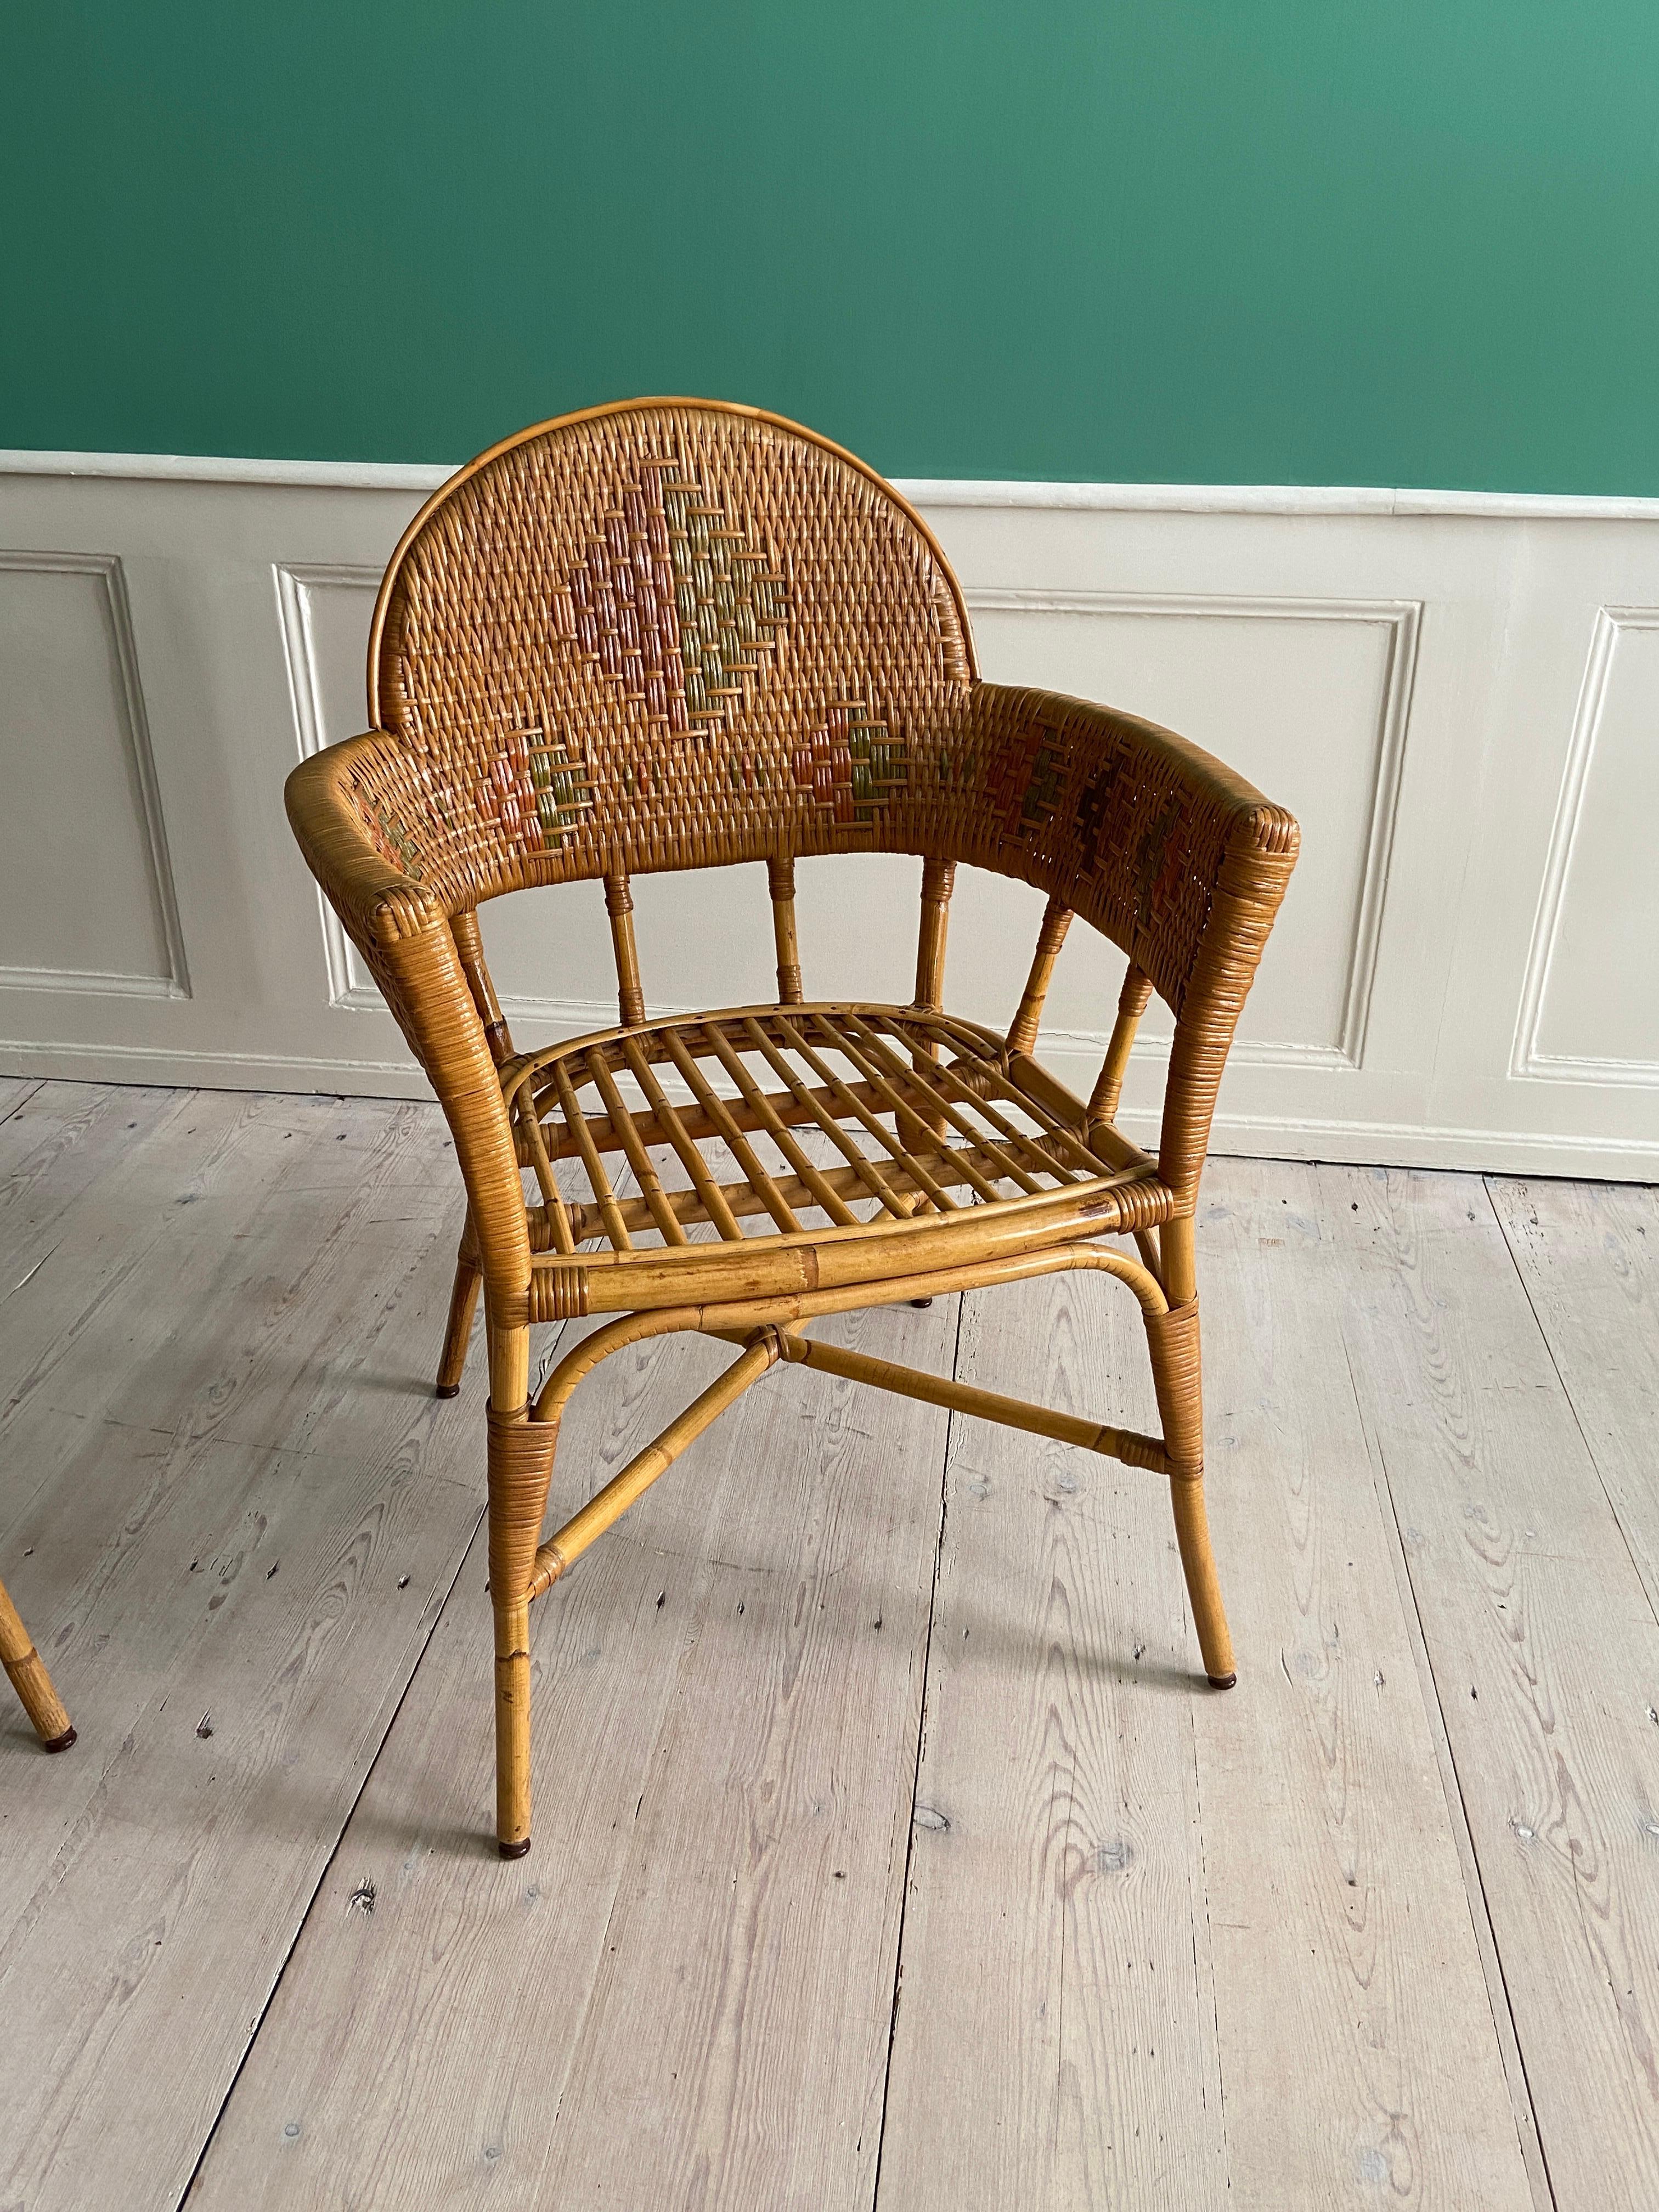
[0,456,1659,1177]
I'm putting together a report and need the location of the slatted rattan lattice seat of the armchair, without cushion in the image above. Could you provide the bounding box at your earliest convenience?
[500,1005,1168,1321]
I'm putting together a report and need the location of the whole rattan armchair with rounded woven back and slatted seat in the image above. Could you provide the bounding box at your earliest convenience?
[287,400,1296,1858]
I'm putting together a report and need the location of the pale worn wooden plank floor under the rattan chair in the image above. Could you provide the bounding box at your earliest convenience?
[0,1080,1659,2212]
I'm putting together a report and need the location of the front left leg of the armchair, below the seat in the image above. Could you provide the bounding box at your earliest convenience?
[489,1329,560,1858]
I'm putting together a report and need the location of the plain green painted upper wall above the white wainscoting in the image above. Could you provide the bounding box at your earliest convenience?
[0,0,1659,493]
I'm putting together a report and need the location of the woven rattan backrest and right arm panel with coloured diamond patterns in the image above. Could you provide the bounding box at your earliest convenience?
[343,400,1294,1033]
